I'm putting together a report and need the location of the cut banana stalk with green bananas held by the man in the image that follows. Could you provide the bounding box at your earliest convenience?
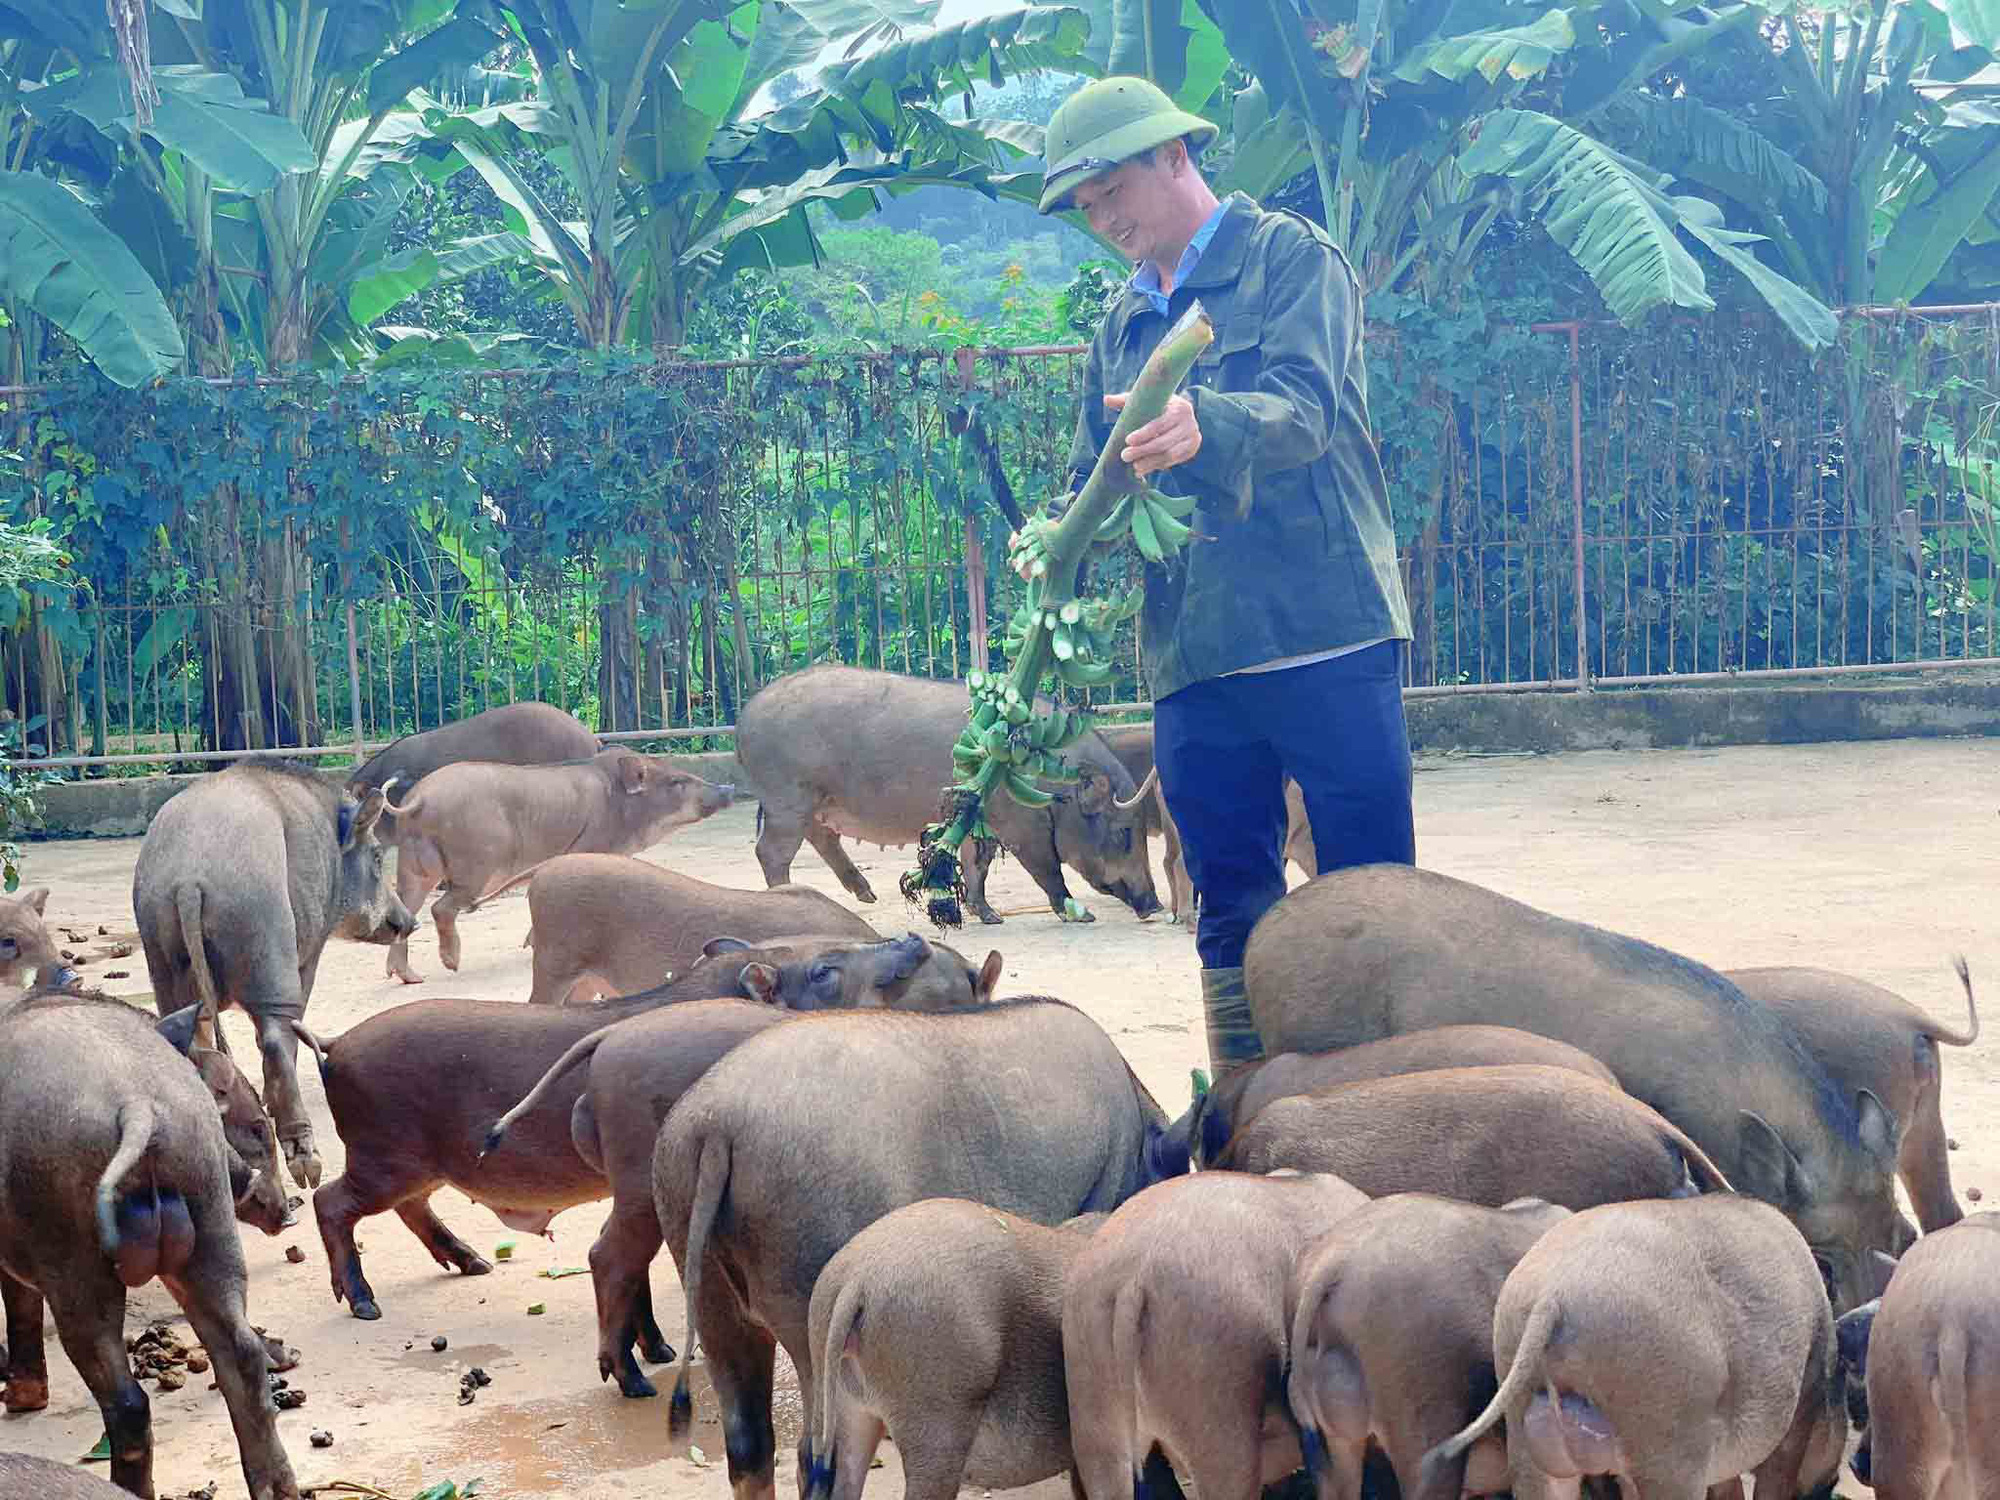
[902,302,1214,928]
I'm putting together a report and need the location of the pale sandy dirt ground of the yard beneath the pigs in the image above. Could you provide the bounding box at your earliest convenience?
[0,740,2000,1500]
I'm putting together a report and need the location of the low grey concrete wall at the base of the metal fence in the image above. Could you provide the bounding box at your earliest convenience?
[23,672,2000,838]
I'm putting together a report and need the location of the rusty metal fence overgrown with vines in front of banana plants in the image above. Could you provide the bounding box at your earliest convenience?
[0,306,2000,764]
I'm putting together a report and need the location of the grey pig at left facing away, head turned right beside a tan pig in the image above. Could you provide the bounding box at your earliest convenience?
[132,756,416,1188]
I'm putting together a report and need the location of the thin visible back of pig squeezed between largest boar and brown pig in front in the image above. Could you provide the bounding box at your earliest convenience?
[1174,1026,1618,1164]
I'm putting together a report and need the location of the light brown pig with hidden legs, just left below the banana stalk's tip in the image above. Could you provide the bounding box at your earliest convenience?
[528,854,878,1004]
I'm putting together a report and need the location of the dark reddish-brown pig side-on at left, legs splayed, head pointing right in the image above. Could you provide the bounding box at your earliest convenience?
[312,938,944,1320]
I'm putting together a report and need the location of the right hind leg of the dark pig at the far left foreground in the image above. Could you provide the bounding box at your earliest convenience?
[162,1224,298,1500]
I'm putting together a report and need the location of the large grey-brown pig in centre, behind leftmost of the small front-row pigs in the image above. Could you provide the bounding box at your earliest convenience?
[652,998,1166,1500]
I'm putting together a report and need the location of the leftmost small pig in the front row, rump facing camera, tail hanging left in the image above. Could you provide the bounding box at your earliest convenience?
[802,1198,1096,1500]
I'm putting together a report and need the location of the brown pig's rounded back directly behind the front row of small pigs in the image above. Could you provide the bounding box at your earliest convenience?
[1216,1064,1730,1208]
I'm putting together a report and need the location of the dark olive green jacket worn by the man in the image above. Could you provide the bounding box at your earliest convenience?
[1070,194,1410,698]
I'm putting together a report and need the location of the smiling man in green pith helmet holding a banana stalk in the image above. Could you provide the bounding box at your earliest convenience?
[1040,78,1416,1072]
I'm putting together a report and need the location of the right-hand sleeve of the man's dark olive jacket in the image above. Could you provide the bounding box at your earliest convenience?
[1182,234,1360,494]
